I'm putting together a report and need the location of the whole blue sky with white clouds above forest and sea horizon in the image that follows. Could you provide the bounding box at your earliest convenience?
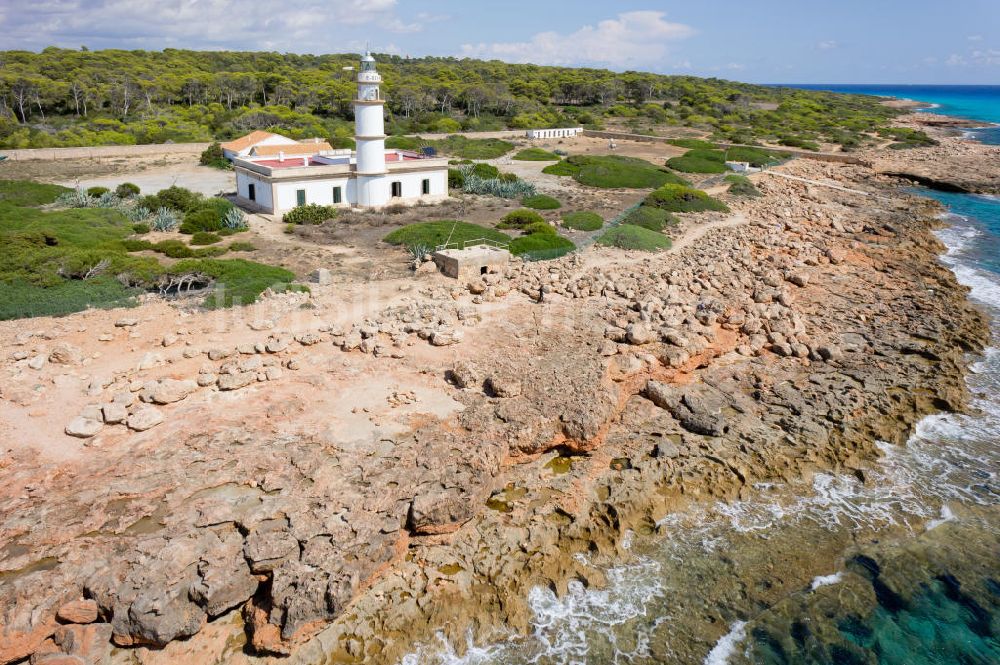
[0,0,1000,84]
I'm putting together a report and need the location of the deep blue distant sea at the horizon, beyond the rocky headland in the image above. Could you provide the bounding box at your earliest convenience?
[789,85,1000,145]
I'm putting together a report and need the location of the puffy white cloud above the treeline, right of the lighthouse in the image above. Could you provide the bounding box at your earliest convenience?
[462,11,695,68]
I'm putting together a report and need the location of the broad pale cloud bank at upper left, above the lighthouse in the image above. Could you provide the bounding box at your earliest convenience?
[0,0,426,52]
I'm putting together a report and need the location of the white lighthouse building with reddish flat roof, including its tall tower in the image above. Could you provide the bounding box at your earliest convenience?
[233,53,448,215]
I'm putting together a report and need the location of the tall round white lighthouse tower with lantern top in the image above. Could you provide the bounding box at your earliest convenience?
[354,51,390,207]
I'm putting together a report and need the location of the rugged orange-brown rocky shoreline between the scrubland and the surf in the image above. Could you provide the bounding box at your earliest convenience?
[0,126,1000,665]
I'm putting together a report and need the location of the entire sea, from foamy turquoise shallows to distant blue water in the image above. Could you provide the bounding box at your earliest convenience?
[402,86,1000,665]
